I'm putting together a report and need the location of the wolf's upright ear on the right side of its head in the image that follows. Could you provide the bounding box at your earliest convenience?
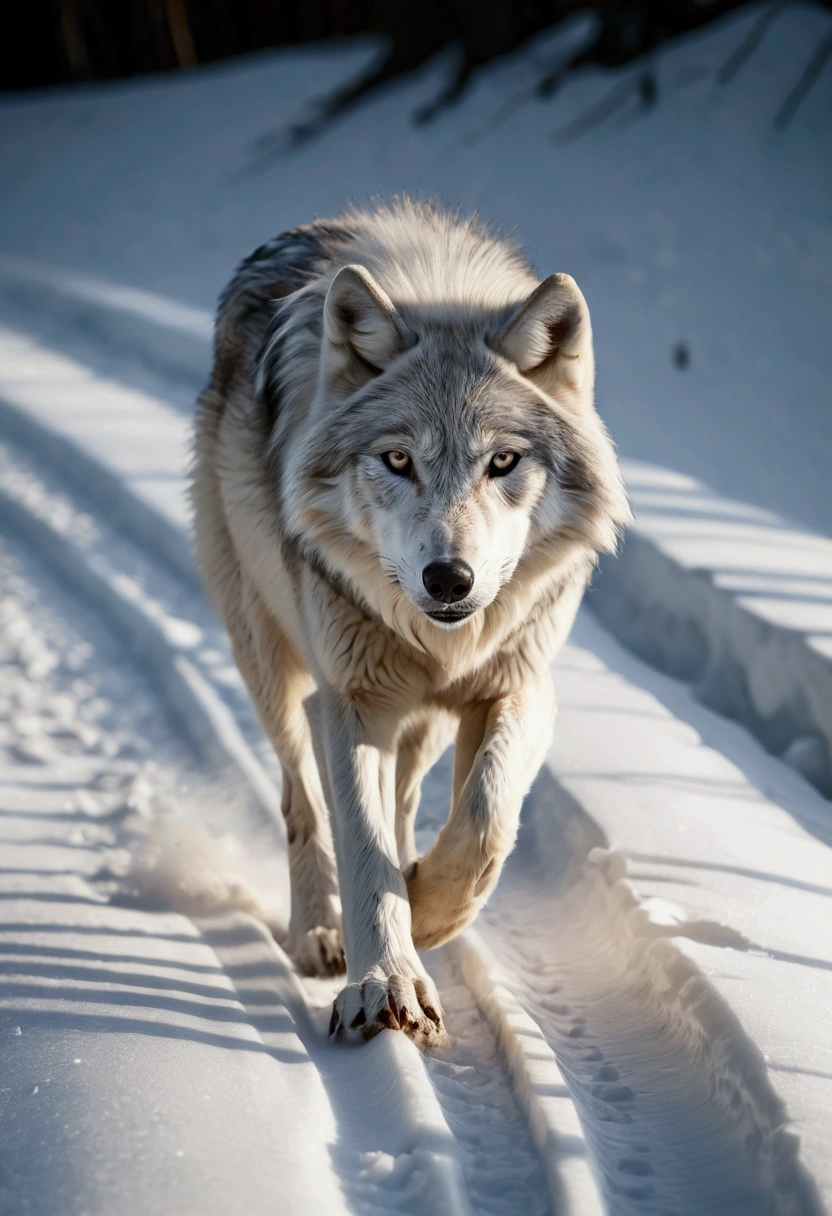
[491,275,595,406]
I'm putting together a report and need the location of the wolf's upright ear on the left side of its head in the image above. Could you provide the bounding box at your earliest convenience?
[324,266,409,393]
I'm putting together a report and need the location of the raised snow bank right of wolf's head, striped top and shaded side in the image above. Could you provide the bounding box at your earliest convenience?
[589,461,832,796]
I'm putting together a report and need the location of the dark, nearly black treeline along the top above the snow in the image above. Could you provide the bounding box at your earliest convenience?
[0,0,832,137]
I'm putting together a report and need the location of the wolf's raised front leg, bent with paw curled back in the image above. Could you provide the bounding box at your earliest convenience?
[407,676,557,950]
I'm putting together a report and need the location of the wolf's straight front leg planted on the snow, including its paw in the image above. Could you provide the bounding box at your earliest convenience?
[321,694,444,1045]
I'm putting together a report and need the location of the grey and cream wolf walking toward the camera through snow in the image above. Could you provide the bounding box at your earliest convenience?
[192,198,630,1046]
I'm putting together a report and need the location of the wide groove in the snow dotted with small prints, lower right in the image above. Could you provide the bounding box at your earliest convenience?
[483,856,776,1216]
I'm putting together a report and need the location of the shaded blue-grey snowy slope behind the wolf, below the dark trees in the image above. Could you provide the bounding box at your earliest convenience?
[0,4,832,531]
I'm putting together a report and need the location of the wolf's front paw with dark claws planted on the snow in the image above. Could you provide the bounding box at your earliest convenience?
[330,970,446,1047]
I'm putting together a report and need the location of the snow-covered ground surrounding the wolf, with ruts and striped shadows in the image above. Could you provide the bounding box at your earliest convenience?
[0,5,832,1216]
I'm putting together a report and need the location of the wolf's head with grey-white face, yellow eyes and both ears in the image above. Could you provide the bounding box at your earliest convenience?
[279,245,629,630]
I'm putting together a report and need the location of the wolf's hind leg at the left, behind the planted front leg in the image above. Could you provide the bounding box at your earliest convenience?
[231,591,345,975]
